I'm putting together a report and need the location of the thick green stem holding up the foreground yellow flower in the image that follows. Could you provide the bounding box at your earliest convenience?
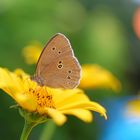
[20,120,37,140]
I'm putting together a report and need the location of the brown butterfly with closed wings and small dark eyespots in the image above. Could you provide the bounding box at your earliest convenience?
[31,33,81,89]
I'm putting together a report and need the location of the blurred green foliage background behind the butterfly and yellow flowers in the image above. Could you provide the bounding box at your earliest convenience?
[0,0,140,140]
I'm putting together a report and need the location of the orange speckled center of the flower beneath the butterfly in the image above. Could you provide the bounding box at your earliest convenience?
[29,86,55,110]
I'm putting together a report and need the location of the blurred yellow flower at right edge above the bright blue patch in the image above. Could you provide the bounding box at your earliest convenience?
[126,98,140,118]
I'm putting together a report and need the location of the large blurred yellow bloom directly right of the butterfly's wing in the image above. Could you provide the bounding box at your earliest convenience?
[80,65,121,91]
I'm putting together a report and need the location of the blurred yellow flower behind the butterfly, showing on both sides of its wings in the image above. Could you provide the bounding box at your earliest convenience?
[23,45,121,92]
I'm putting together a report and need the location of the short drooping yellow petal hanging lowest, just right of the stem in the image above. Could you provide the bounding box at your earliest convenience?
[46,108,67,125]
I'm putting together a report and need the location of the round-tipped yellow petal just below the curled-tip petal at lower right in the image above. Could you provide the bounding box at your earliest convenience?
[62,109,93,123]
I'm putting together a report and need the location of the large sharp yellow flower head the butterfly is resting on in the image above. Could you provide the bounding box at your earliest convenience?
[0,68,107,125]
